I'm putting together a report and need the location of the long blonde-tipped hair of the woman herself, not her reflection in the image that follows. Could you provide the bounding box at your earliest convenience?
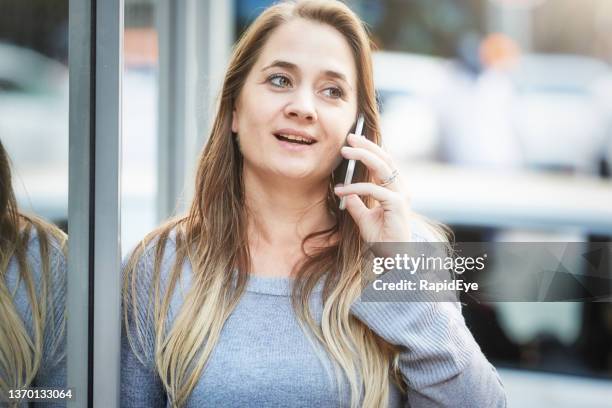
[123,0,440,407]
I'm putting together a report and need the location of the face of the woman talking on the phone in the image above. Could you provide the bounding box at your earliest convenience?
[232,19,357,183]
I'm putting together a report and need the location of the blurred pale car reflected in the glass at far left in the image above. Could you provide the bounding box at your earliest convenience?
[0,42,68,223]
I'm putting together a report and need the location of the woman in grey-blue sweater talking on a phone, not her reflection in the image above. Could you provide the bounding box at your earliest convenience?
[121,1,505,407]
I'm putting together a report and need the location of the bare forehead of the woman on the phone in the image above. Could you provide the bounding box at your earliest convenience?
[257,19,356,84]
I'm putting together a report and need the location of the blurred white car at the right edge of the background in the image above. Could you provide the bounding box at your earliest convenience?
[509,54,612,174]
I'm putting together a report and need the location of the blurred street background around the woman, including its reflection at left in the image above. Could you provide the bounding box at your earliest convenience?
[0,0,612,407]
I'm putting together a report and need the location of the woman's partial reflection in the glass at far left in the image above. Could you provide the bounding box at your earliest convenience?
[0,142,66,406]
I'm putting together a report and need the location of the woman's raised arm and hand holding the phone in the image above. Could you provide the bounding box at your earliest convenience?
[334,135,506,408]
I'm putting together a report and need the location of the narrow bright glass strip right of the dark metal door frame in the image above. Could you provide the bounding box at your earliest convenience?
[121,1,159,254]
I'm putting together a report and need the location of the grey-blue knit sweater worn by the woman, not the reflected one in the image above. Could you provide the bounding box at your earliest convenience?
[121,231,506,408]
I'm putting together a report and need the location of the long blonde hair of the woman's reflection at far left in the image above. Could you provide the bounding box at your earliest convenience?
[0,142,66,406]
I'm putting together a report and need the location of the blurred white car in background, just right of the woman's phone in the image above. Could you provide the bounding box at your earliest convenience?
[373,51,522,168]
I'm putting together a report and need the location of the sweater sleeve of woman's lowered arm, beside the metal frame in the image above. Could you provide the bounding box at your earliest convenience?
[120,244,167,408]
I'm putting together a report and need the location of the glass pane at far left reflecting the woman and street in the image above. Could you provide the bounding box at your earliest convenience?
[0,0,68,407]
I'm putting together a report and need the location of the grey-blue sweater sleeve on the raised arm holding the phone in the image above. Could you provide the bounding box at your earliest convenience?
[351,223,506,408]
